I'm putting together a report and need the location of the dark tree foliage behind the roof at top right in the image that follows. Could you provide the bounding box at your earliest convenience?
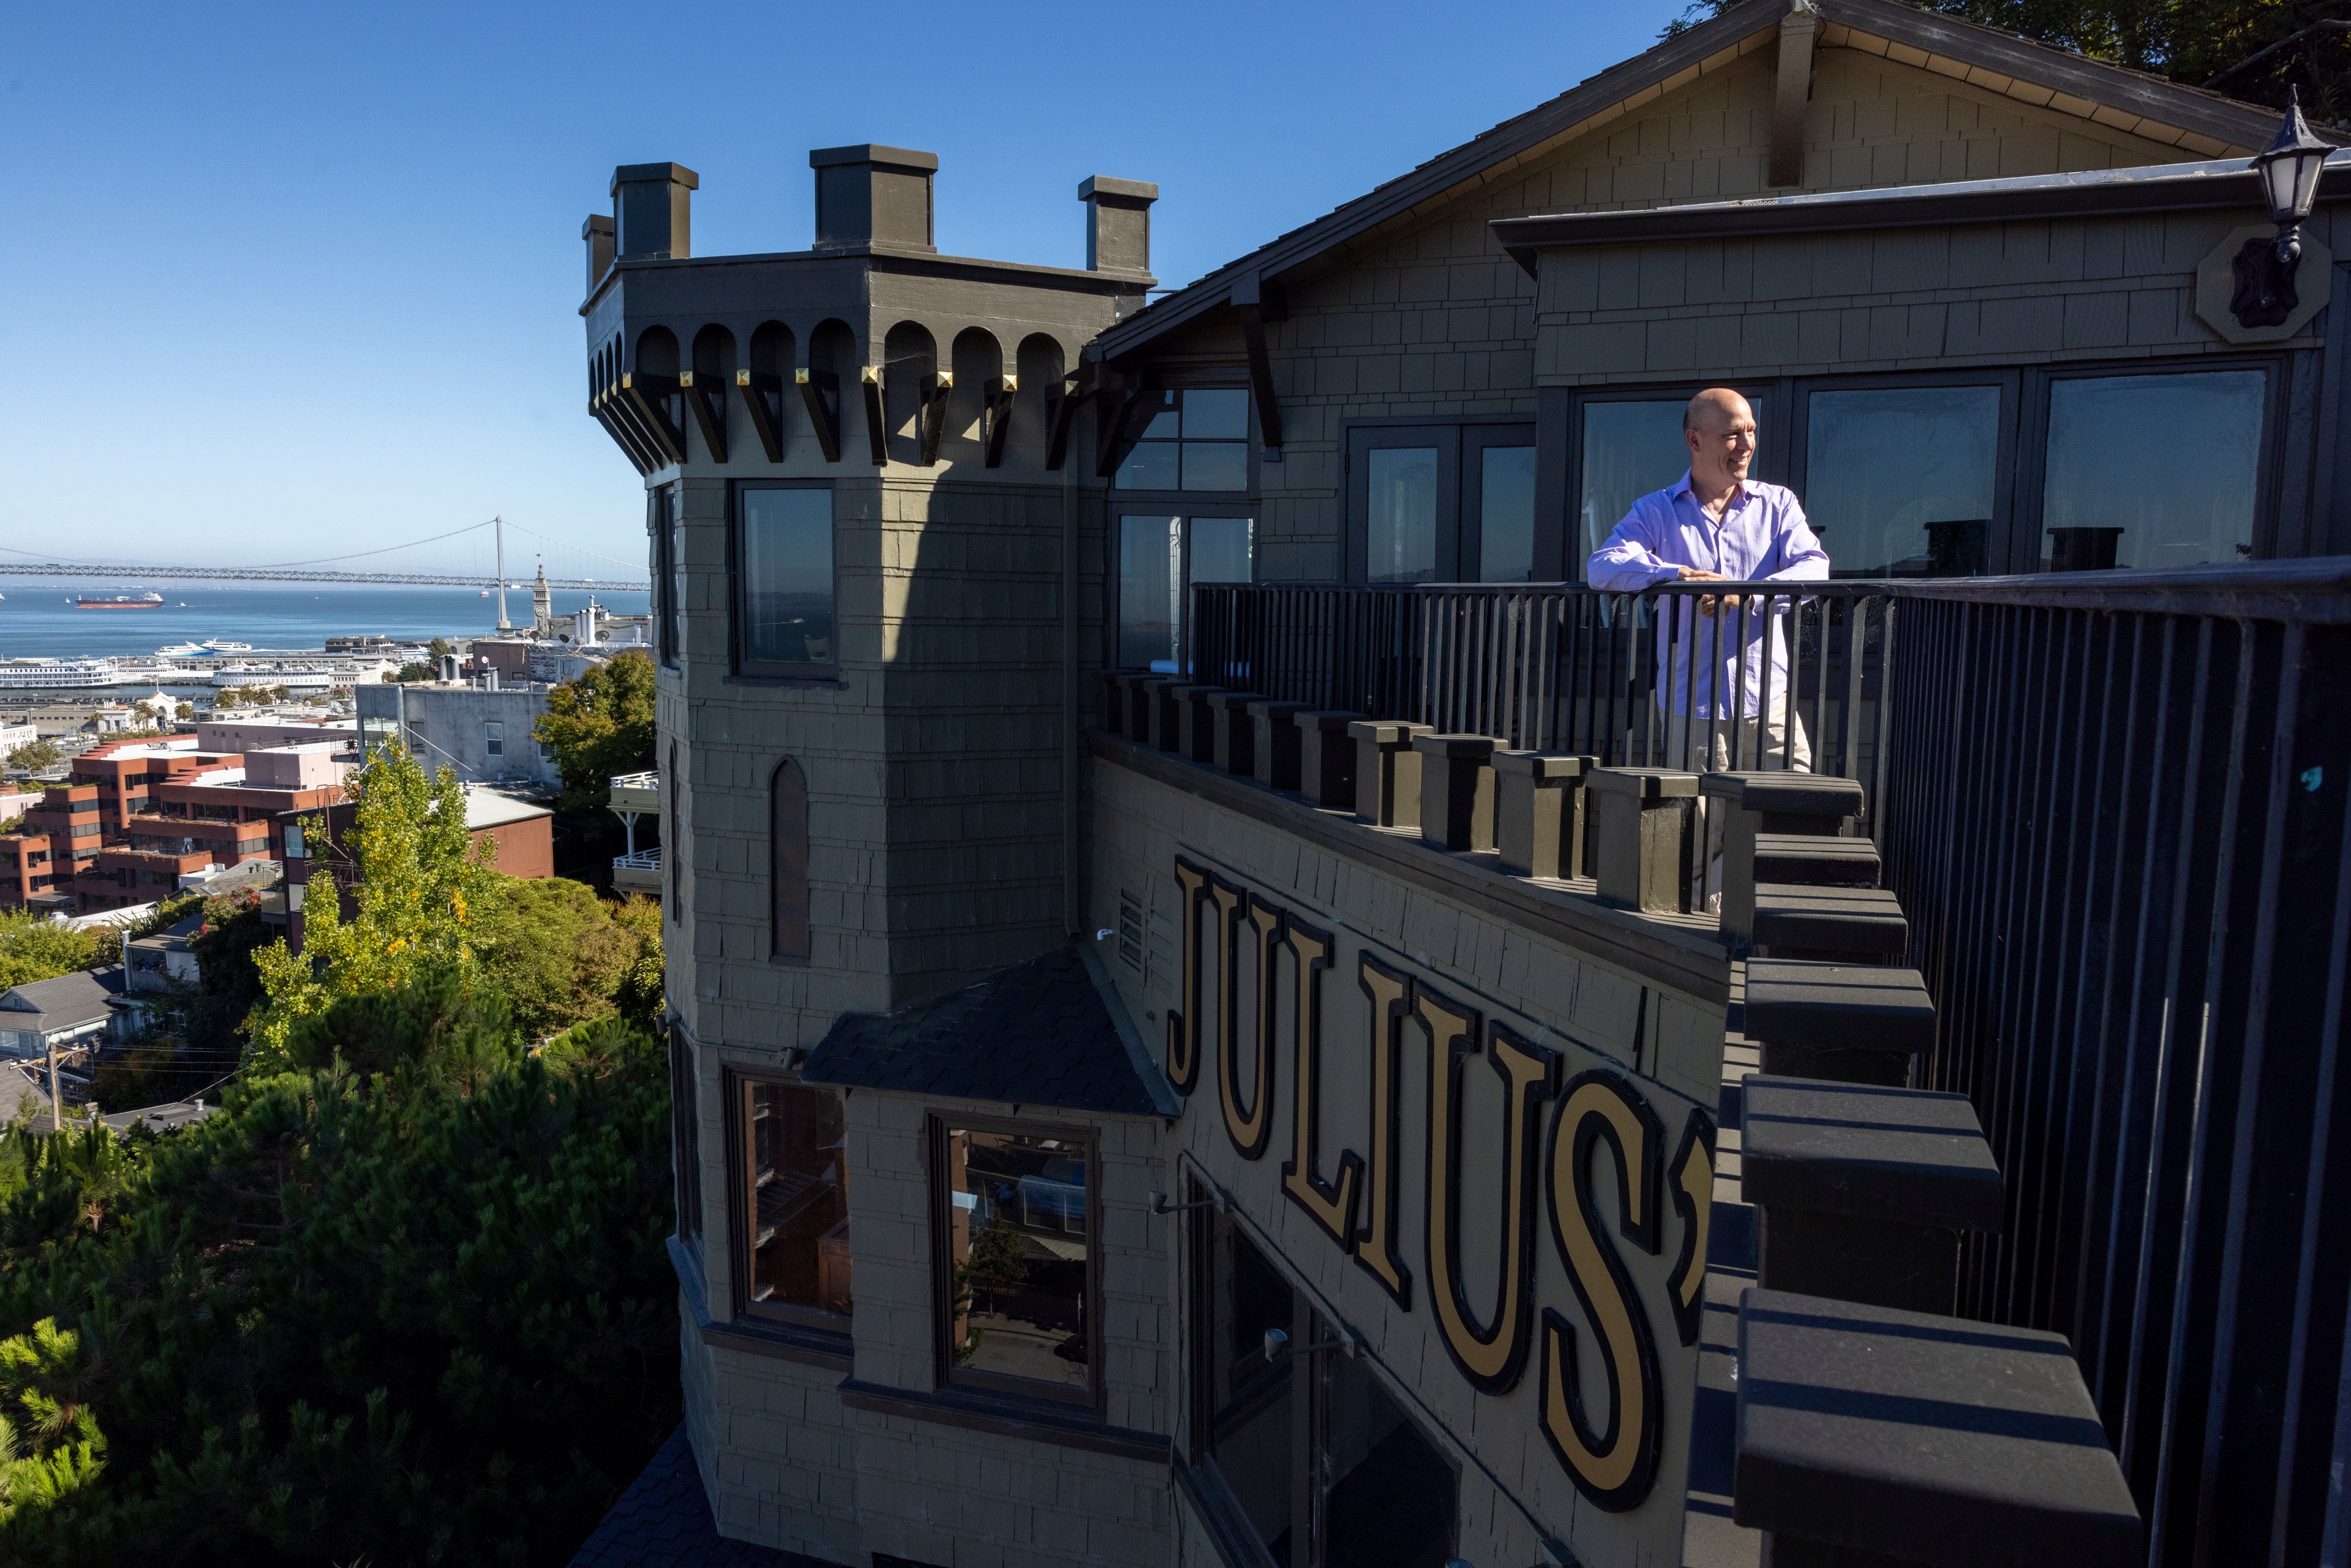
[1665,0,2351,124]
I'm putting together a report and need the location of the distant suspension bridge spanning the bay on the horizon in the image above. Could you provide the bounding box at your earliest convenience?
[0,517,651,593]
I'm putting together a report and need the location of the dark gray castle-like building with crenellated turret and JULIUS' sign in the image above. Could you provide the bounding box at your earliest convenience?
[597,0,2351,1568]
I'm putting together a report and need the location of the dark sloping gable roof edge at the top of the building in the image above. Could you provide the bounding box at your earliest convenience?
[1088,0,2337,359]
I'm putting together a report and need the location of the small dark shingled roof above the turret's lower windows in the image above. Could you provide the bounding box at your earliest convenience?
[799,945,1171,1117]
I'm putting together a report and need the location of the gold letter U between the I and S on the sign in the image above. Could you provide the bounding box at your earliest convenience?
[1413,1001,1559,1394]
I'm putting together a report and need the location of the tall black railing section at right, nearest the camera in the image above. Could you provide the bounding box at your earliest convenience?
[1881,560,2351,1563]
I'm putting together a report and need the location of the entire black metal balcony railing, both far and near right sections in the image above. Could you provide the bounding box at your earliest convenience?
[1192,560,2351,1566]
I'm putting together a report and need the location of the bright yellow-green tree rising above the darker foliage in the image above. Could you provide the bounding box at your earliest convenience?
[247,740,496,1062]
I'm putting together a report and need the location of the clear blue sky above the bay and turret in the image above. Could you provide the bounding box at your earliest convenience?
[0,0,1681,576]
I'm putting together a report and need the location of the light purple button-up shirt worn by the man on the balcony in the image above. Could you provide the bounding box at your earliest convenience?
[1584,473,1829,719]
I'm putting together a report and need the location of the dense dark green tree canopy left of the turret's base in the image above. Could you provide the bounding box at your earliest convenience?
[0,969,677,1568]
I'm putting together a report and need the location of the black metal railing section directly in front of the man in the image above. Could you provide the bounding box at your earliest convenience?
[1192,580,1892,832]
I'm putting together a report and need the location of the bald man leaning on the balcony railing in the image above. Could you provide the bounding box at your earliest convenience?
[1584,386,1829,771]
